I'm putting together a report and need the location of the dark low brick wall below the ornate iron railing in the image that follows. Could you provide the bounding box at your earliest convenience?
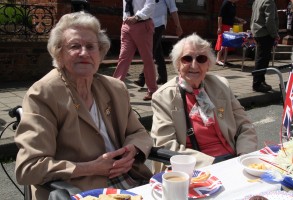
[0,42,52,82]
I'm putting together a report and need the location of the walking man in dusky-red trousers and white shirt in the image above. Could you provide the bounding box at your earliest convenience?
[113,0,158,101]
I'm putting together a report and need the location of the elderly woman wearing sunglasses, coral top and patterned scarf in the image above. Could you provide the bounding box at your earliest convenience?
[151,34,257,172]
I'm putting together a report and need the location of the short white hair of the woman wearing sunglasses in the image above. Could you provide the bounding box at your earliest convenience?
[170,33,216,71]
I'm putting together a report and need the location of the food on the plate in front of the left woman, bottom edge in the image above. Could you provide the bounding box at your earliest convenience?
[81,194,142,200]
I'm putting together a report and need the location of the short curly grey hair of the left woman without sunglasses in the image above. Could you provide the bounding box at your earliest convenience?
[47,11,110,67]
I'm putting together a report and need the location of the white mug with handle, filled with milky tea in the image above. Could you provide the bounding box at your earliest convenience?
[151,171,189,200]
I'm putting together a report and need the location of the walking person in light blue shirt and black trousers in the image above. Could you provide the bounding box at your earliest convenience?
[134,0,183,87]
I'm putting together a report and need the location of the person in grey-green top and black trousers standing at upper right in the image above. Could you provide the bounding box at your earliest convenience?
[250,0,280,92]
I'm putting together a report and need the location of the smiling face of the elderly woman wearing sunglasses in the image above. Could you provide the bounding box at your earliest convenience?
[179,44,209,88]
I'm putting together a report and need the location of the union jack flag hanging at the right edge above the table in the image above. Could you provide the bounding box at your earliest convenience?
[280,72,293,138]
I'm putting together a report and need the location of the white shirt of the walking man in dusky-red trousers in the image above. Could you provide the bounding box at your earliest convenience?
[123,0,156,21]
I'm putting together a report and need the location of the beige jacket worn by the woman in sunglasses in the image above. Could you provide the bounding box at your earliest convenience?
[151,74,257,173]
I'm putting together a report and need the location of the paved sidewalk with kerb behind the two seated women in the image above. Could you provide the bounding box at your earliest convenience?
[0,52,291,200]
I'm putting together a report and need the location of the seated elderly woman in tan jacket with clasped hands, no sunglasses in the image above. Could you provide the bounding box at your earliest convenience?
[15,12,152,200]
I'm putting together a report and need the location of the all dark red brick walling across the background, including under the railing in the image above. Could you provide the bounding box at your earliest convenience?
[0,0,288,82]
